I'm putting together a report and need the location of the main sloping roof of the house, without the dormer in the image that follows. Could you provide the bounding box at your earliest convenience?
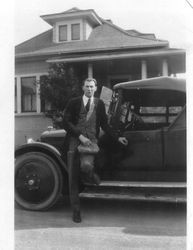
[16,20,168,57]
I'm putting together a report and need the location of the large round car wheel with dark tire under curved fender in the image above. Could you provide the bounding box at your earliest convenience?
[15,152,63,210]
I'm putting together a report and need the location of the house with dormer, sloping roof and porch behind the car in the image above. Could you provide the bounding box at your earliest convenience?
[15,8,185,145]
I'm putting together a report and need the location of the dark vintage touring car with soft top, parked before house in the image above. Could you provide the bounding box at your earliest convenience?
[15,77,186,210]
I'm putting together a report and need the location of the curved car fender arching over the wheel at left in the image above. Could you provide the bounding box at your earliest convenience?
[15,142,68,172]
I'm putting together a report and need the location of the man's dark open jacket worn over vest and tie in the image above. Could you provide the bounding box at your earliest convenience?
[63,96,118,139]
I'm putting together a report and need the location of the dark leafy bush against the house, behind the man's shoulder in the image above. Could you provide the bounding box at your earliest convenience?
[39,63,81,127]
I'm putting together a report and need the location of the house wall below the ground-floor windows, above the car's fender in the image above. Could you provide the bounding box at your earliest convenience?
[15,114,52,146]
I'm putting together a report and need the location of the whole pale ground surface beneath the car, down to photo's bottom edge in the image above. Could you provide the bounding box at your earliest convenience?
[15,199,186,250]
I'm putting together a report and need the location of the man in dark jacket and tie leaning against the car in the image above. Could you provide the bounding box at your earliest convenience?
[64,78,128,222]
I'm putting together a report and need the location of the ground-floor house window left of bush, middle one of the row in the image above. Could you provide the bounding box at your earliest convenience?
[21,77,36,112]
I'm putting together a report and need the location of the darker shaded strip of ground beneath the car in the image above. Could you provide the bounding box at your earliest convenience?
[15,198,186,236]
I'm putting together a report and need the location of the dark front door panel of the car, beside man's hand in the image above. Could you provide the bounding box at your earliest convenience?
[119,129,163,170]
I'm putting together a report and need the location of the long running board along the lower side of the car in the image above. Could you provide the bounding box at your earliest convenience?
[80,181,186,202]
